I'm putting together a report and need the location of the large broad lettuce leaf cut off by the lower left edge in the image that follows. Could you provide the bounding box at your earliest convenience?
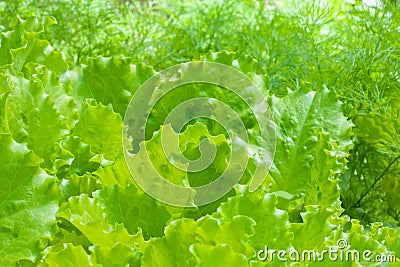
[0,134,59,266]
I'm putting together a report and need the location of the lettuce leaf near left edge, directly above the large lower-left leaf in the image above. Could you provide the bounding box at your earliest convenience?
[5,76,67,169]
